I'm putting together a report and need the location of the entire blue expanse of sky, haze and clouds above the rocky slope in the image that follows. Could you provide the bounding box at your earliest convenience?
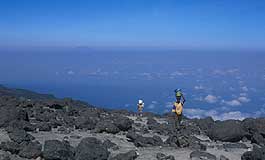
[0,0,265,120]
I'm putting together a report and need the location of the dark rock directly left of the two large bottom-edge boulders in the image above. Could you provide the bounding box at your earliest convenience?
[18,142,41,159]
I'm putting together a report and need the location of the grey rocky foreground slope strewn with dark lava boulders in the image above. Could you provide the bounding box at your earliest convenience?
[0,92,265,160]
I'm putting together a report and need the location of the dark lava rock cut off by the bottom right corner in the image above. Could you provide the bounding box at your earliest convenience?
[241,146,265,160]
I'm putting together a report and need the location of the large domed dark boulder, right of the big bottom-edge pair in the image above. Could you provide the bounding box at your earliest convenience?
[75,137,110,160]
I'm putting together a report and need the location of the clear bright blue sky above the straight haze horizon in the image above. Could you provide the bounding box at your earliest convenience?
[0,0,265,49]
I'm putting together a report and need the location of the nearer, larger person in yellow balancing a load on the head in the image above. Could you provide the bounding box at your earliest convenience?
[172,89,186,129]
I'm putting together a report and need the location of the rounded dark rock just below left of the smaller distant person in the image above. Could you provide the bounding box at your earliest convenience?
[114,116,133,131]
